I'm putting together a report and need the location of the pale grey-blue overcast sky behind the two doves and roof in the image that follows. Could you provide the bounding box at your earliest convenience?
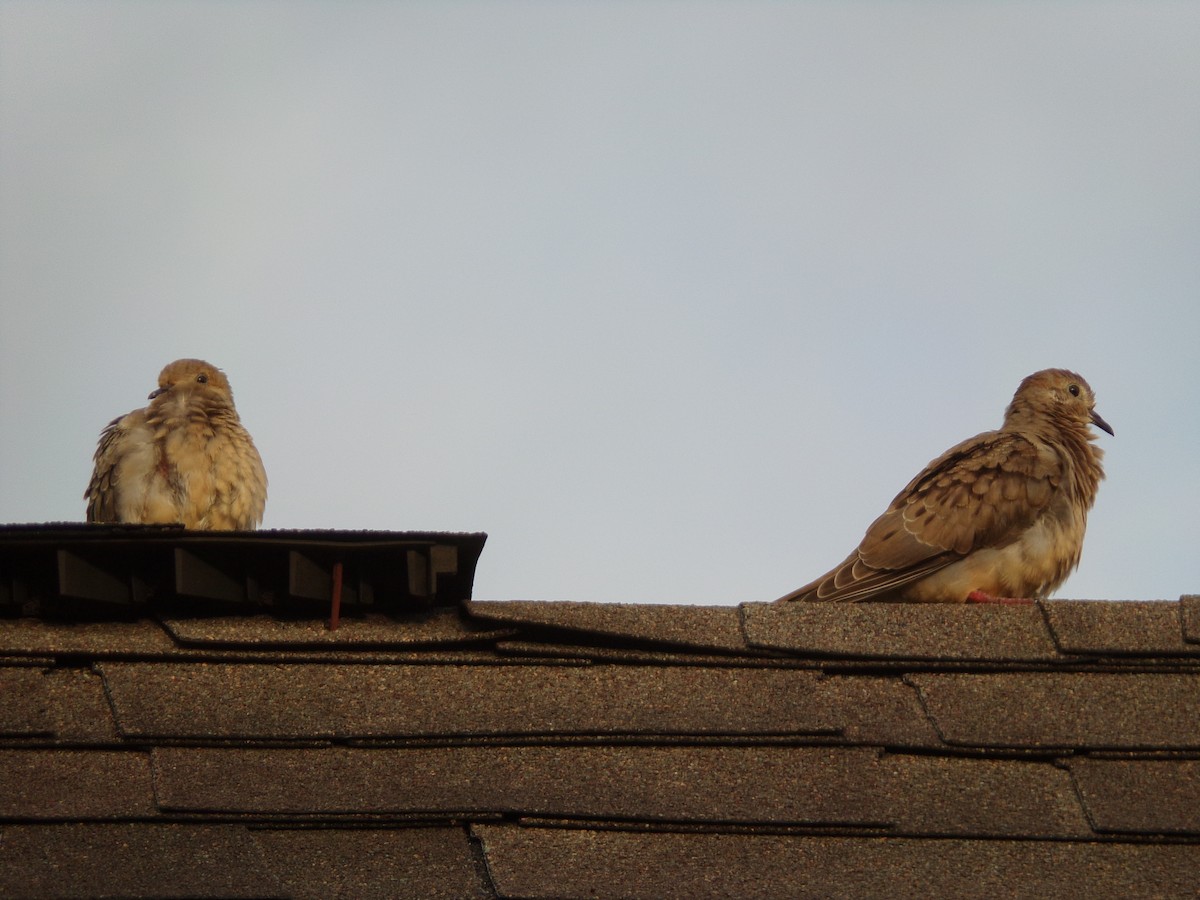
[0,0,1200,604]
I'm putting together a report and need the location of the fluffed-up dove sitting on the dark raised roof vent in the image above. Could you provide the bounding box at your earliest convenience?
[84,359,266,530]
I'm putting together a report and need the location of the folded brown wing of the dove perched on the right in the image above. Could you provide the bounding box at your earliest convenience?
[780,431,1063,601]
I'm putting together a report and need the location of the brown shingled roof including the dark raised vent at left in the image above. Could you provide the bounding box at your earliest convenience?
[0,526,1200,898]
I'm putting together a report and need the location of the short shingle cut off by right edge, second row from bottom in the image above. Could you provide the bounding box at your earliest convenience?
[1069,757,1200,834]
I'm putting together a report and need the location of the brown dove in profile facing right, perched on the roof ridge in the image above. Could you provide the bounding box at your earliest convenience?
[776,368,1114,602]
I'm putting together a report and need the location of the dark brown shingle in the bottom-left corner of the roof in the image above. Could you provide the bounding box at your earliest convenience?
[0,823,286,900]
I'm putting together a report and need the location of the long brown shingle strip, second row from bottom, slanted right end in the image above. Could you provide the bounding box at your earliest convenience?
[154,745,1092,838]
